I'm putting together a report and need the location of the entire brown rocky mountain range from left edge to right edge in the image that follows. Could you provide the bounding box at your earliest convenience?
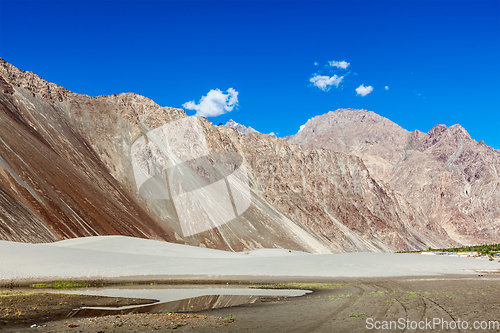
[0,60,500,253]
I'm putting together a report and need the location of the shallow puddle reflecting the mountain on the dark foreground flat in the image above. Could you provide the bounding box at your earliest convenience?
[43,285,311,318]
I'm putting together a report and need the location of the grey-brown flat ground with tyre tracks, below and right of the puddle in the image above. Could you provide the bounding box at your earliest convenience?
[0,275,500,332]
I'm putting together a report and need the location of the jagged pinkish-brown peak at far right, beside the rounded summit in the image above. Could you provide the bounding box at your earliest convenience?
[387,125,500,244]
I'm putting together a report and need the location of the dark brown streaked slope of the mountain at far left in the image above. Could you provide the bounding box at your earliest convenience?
[0,62,174,242]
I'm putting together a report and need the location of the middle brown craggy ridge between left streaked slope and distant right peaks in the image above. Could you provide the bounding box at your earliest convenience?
[207,120,454,252]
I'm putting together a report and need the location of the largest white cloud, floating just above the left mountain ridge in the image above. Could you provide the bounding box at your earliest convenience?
[182,88,238,117]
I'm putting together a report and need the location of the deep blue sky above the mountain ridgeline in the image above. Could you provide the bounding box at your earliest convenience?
[0,0,500,149]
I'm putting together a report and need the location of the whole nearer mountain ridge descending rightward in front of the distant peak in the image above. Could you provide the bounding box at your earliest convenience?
[0,61,454,253]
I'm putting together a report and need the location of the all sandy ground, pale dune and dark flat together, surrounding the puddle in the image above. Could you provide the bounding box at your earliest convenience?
[0,236,500,332]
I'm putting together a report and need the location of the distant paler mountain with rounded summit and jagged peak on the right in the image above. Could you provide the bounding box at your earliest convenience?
[286,109,500,244]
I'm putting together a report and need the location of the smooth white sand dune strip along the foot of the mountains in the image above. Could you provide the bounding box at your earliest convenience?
[0,236,500,282]
